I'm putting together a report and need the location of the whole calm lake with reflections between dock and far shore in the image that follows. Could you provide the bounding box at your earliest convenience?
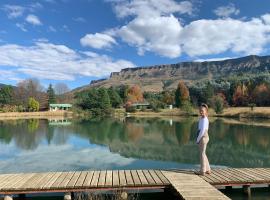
[0,117,270,173]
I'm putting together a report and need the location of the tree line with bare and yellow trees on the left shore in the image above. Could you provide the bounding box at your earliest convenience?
[0,79,73,112]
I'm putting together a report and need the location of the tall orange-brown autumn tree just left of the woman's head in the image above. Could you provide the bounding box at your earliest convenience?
[175,81,190,108]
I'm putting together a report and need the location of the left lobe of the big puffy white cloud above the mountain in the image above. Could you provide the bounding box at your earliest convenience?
[118,15,182,58]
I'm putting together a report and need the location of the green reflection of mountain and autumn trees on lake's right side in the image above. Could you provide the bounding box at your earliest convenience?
[72,118,270,167]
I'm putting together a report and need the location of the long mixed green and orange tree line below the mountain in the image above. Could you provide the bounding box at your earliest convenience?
[75,74,270,114]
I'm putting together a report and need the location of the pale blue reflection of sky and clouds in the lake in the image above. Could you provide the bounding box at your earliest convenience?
[0,131,190,173]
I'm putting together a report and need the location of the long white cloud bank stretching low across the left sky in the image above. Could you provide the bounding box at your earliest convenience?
[0,42,135,80]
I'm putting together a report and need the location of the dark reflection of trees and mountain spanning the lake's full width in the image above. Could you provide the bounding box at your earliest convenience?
[0,118,270,167]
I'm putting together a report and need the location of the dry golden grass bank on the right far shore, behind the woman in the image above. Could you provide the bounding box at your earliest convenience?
[122,107,270,119]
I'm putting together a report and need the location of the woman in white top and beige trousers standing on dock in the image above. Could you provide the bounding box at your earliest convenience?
[196,103,211,175]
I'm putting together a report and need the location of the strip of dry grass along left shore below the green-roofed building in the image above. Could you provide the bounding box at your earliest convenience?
[0,111,72,120]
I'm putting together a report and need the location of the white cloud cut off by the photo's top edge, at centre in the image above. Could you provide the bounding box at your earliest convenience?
[110,0,193,18]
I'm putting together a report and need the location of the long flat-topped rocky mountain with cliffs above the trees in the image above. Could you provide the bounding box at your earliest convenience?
[75,55,270,92]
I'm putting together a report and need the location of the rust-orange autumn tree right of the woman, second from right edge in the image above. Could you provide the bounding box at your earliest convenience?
[233,83,249,106]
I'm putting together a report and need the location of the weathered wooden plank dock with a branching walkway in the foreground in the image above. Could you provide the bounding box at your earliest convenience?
[0,168,270,200]
